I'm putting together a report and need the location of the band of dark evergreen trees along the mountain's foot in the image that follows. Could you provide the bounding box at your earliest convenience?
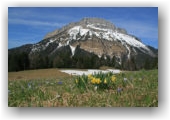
[8,51,158,71]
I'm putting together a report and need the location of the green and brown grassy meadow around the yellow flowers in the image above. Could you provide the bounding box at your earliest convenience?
[8,69,158,107]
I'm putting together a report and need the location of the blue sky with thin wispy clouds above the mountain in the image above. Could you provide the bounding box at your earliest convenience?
[8,7,158,48]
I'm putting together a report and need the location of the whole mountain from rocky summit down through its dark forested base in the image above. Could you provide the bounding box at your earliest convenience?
[8,18,158,71]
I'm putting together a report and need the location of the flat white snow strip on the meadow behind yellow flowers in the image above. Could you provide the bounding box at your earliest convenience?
[60,69,121,75]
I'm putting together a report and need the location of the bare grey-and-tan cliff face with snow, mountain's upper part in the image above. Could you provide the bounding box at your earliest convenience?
[32,18,155,58]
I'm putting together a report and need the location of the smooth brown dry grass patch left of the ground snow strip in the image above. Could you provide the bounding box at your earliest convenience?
[8,68,70,80]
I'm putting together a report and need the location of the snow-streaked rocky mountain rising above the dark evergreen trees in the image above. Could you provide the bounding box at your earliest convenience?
[8,18,157,68]
